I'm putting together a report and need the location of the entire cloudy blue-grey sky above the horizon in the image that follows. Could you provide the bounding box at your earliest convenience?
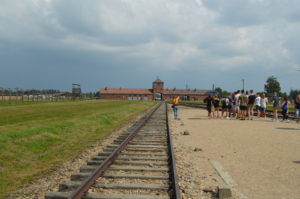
[0,0,300,92]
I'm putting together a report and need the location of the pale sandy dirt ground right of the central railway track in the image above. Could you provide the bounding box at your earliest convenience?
[169,106,300,199]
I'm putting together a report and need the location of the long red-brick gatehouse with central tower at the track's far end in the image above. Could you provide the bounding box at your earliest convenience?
[100,78,214,101]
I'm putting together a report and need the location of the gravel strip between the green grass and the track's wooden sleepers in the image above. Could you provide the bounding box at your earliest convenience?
[7,110,154,199]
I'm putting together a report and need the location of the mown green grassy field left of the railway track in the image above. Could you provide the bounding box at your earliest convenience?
[0,100,154,198]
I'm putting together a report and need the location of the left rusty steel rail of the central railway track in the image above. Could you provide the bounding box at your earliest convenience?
[68,103,162,199]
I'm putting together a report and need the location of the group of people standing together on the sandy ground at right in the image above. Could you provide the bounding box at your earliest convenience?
[204,90,300,121]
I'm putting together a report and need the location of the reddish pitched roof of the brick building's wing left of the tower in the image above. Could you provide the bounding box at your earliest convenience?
[100,88,153,95]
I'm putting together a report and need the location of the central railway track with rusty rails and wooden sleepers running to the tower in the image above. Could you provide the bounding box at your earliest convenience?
[45,103,180,199]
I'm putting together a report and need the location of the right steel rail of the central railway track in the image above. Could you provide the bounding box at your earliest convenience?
[166,103,181,199]
